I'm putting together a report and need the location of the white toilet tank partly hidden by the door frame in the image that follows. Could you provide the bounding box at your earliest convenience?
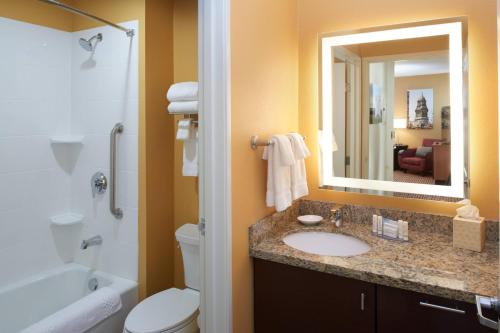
[175,224,200,290]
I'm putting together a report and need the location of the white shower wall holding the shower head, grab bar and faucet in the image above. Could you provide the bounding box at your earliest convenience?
[71,22,139,280]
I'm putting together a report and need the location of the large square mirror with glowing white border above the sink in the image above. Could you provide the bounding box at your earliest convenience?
[320,22,467,201]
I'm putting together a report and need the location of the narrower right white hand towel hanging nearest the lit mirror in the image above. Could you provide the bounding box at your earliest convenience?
[287,133,311,200]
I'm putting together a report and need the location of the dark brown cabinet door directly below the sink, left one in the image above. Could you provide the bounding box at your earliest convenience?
[254,259,375,333]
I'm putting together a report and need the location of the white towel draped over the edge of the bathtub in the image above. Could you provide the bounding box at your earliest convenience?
[21,287,122,333]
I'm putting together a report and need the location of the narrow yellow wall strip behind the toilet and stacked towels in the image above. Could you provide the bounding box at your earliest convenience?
[173,0,198,288]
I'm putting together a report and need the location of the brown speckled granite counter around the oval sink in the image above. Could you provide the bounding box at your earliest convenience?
[250,201,498,303]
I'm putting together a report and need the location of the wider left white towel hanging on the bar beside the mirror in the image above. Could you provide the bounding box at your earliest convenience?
[262,135,295,212]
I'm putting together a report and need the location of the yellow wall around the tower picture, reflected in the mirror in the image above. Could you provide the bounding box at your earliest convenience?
[394,74,450,148]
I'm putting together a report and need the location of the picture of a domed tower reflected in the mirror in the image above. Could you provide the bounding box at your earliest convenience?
[407,89,434,129]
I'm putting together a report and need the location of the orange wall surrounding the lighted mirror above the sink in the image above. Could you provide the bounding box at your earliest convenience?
[298,0,499,219]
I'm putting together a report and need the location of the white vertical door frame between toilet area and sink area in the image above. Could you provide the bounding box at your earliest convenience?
[198,0,232,333]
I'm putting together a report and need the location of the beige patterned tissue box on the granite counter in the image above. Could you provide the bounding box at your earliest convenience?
[453,216,486,252]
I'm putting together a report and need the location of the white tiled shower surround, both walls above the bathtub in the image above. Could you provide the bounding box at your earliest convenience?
[0,18,139,286]
